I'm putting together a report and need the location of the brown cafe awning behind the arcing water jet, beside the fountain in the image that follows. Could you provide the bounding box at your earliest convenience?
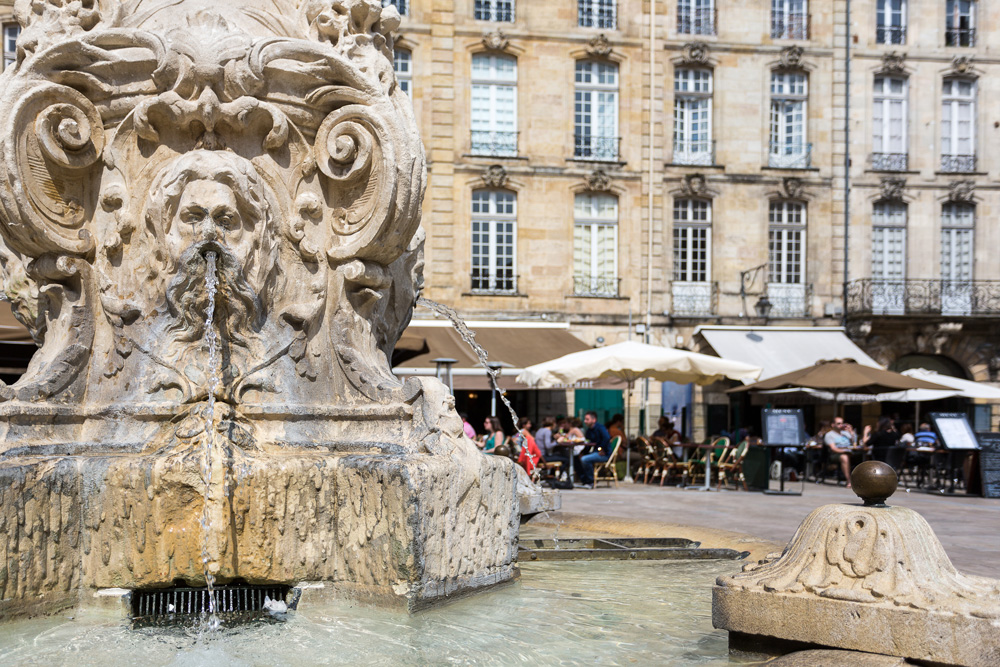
[393,320,625,390]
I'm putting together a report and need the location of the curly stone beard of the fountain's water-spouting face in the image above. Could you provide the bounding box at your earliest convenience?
[166,242,264,347]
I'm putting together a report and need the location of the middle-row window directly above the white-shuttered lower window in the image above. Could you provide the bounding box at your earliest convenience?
[573,61,618,161]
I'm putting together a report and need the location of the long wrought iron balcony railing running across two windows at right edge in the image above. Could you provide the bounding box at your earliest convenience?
[847,278,1000,317]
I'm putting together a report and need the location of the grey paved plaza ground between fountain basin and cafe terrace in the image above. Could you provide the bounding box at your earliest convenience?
[525,482,1000,578]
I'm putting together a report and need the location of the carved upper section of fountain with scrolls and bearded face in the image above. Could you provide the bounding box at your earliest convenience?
[0,0,426,440]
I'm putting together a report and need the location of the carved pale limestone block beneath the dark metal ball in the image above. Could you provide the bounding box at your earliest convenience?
[712,504,1000,666]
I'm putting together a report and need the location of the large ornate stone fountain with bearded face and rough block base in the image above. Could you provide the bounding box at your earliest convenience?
[0,0,517,616]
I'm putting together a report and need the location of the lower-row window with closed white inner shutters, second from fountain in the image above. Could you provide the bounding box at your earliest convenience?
[573,193,618,296]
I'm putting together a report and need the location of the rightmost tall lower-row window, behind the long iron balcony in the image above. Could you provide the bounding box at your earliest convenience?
[941,202,976,315]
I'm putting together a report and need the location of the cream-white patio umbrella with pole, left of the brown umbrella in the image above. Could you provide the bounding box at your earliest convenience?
[517,341,763,480]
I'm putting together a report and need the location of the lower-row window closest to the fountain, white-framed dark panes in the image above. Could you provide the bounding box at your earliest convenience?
[472,190,517,294]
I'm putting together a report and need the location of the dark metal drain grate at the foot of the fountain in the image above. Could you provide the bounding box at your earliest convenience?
[132,584,290,625]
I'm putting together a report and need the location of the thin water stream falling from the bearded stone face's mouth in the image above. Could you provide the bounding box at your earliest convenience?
[201,252,221,631]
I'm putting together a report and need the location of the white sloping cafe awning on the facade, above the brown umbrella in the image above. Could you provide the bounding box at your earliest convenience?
[694,326,882,380]
